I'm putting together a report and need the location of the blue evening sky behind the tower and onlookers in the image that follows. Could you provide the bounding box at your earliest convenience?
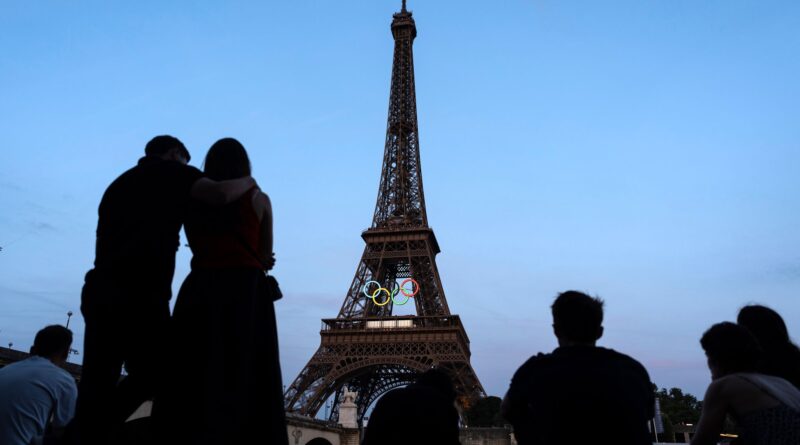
[0,0,800,396]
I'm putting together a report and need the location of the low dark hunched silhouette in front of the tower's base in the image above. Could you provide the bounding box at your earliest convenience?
[361,369,460,445]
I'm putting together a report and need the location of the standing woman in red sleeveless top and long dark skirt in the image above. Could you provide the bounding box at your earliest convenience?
[153,138,288,445]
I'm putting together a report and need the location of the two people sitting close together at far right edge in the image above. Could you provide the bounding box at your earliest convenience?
[692,305,800,445]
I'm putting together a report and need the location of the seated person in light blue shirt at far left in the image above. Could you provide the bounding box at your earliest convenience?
[0,325,78,445]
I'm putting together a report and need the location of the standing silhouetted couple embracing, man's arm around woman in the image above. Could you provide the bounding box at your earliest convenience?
[73,136,288,444]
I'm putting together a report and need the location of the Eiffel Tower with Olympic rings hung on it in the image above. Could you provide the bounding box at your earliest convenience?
[285,0,485,424]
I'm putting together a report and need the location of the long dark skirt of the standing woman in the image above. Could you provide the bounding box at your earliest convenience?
[155,268,288,445]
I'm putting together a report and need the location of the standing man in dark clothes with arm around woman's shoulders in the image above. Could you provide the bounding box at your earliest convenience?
[70,136,255,445]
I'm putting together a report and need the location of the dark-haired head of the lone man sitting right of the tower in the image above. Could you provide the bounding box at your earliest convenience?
[551,290,603,346]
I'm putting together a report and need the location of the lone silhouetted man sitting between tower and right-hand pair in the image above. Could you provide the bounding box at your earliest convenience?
[502,291,655,445]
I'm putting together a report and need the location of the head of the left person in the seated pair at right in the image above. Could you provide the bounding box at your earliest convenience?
[700,321,761,379]
